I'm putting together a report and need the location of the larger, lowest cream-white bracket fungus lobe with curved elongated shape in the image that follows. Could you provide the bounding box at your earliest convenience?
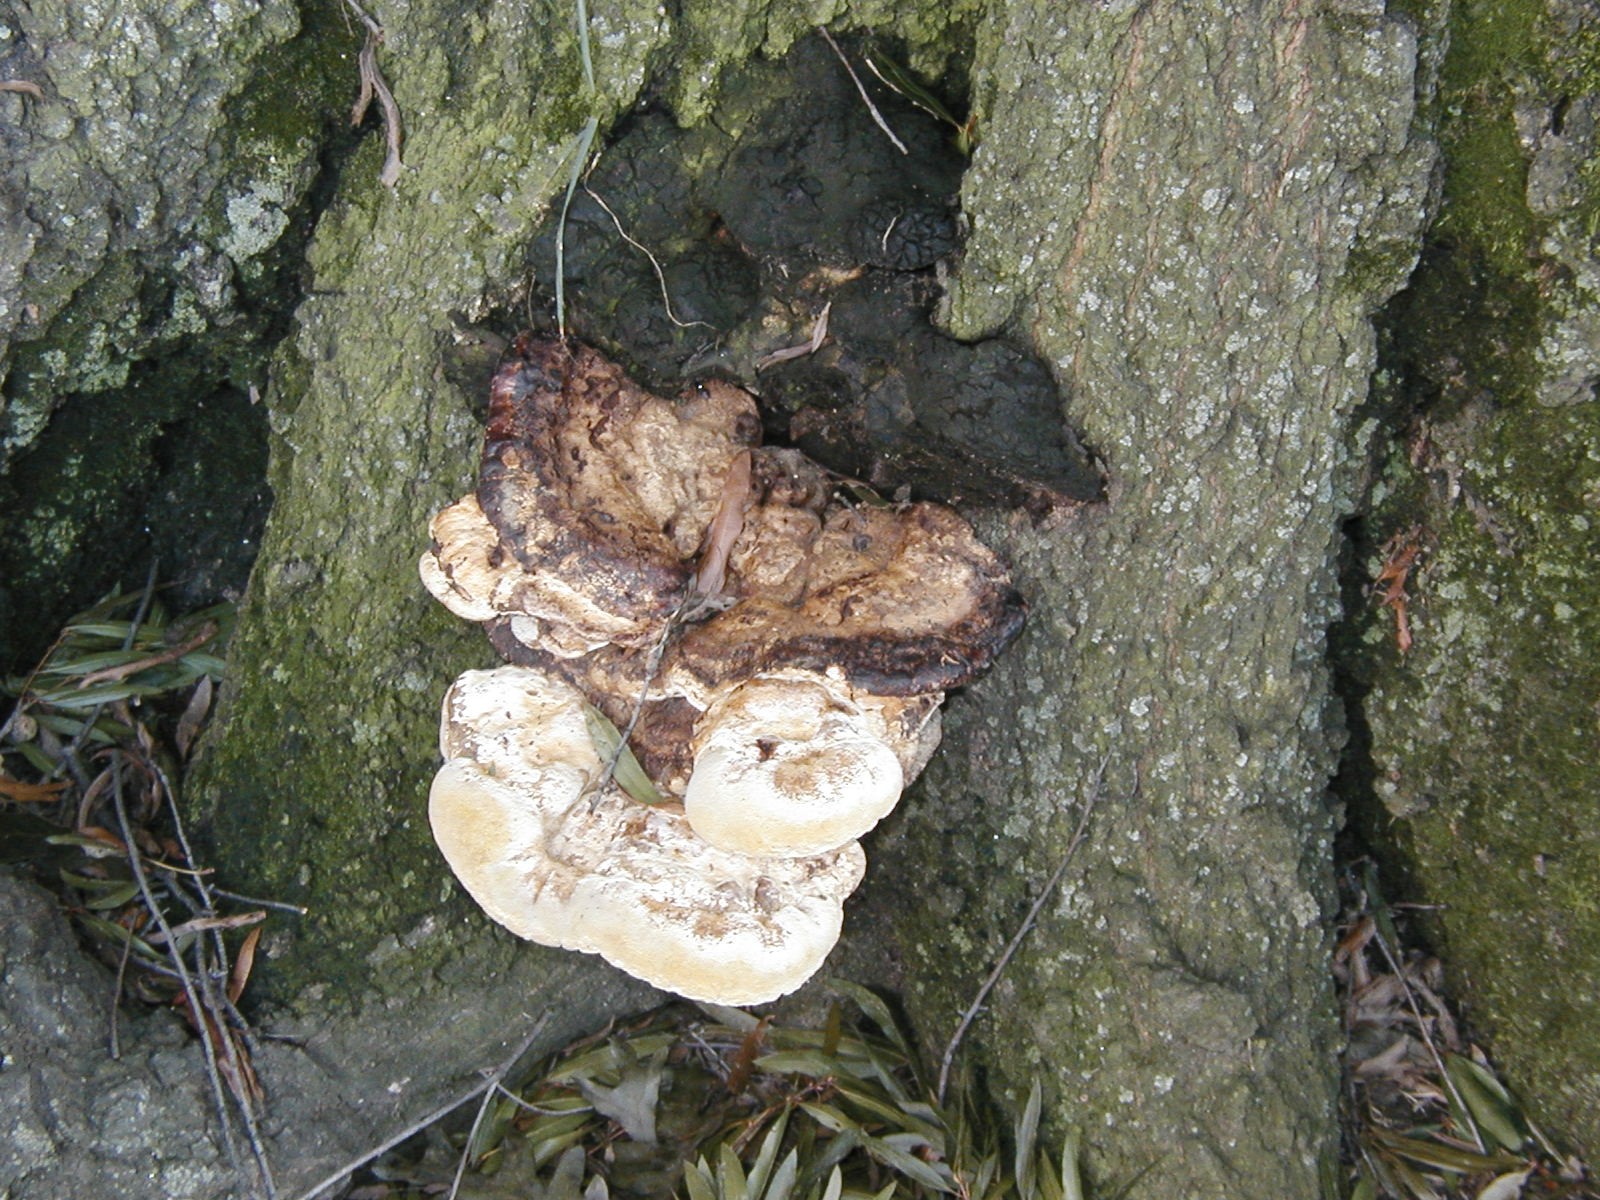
[429,667,866,1005]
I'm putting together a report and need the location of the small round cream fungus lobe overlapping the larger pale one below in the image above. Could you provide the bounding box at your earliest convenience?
[683,674,906,854]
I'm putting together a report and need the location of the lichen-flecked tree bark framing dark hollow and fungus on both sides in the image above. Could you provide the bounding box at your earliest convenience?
[0,0,1430,1197]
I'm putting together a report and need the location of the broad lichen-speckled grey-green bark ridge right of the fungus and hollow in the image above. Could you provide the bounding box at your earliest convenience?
[880,3,1432,1197]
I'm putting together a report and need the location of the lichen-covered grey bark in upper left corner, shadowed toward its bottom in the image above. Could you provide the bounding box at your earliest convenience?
[0,0,349,661]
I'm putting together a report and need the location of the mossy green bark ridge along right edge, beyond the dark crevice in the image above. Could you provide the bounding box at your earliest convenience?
[1350,0,1600,1149]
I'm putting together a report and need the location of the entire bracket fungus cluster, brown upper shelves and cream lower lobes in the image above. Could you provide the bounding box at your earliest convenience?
[421,336,1024,1003]
